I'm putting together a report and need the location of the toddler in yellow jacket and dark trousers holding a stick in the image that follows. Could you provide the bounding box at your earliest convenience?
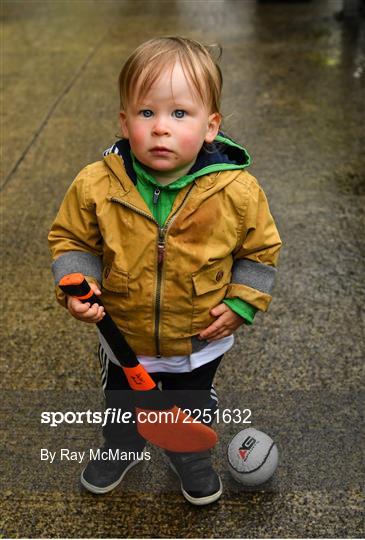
[49,37,281,505]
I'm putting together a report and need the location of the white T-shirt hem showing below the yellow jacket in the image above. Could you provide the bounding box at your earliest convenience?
[98,331,234,373]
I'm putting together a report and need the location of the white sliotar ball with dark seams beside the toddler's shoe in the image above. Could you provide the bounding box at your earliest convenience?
[227,428,279,486]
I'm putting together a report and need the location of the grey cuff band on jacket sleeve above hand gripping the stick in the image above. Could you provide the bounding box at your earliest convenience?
[52,251,103,285]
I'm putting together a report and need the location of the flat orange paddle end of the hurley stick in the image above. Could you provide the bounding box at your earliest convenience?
[136,405,218,452]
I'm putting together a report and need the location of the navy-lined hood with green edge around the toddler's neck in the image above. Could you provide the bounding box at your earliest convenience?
[103,132,251,184]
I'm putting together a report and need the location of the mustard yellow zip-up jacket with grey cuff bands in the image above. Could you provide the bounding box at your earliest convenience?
[49,150,281,356]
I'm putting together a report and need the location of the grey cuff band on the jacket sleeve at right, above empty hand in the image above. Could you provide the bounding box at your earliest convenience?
[232,259,277,294]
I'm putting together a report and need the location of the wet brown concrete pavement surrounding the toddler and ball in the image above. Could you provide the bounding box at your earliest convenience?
[0,0,365,538]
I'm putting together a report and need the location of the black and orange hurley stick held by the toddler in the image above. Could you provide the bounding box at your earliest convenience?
[59,274,218,452]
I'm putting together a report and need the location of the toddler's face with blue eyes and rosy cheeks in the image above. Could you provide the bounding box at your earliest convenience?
[120,63,221,184]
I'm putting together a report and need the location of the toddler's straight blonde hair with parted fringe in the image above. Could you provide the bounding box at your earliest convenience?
[119,36,223,113]
